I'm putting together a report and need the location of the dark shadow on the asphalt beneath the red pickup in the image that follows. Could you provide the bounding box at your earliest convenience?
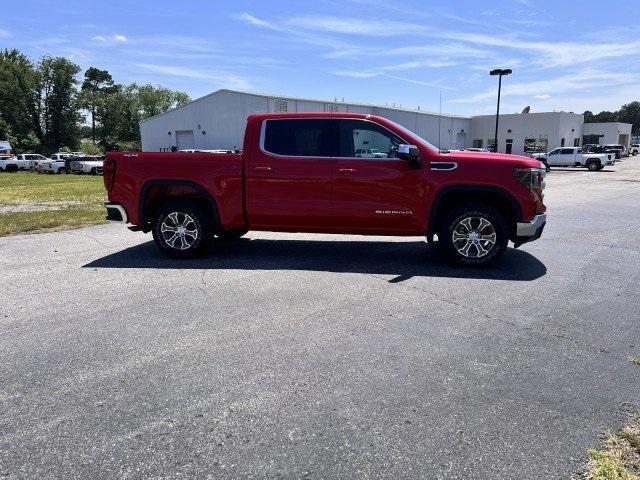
[84,238,547,283]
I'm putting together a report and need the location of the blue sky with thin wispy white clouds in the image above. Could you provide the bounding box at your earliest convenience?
[0,0,640,115]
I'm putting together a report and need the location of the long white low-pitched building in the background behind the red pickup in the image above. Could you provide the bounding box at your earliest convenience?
[140,89,631,154]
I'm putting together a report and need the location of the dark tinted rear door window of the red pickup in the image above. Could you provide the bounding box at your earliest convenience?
[264,119,338,157]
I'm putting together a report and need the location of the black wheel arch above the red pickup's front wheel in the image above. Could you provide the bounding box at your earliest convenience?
[427,185,522,240]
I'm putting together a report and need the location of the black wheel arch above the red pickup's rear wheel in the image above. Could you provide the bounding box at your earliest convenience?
[138,179,222,233]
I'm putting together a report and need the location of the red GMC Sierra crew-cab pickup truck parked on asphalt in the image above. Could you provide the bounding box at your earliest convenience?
[104,113,546,265]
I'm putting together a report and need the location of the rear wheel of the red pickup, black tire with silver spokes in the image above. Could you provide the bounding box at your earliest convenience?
[153,200,213,259]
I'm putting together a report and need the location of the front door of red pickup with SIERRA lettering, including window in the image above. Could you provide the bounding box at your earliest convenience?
[331,119,428,233]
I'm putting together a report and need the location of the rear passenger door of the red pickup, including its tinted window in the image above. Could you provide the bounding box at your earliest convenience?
[246,118,338,231]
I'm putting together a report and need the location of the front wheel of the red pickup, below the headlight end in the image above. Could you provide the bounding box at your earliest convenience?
[438,203,509,267]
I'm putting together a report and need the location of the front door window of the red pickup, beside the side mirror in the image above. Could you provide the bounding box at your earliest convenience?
[340,120,406,160]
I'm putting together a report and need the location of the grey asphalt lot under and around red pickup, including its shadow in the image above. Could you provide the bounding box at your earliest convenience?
[0,159,640,479]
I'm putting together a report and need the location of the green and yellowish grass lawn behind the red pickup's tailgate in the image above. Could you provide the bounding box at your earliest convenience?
[0,172,106,236]
